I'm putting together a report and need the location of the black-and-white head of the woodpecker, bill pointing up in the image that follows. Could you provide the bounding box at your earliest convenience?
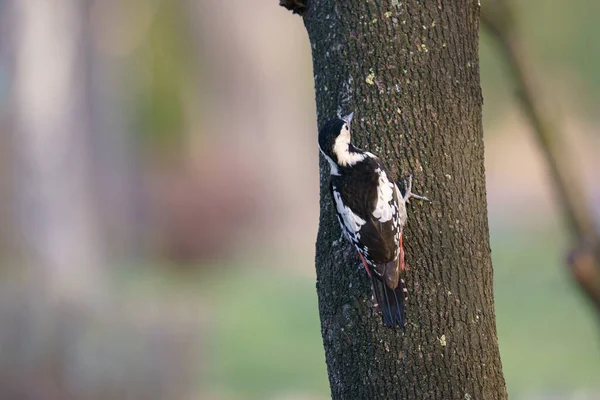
[319,113,365,175]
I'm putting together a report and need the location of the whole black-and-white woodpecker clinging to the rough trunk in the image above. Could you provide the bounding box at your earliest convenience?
[319,113,429,327]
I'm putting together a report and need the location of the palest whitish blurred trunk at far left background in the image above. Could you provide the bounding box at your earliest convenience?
[13,0,104,301]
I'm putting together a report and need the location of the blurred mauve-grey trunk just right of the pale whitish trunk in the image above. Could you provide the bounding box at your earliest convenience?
[85,0,148,266]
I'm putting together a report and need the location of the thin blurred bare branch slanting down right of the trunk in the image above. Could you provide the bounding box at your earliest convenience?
[481,0,600,312]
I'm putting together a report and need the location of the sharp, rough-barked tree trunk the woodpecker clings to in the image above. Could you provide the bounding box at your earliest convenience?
[281,0,507,400]
